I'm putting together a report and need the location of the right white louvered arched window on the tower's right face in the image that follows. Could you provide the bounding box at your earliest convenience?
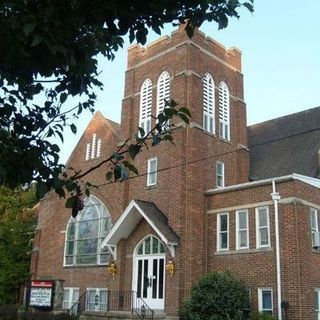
[219,81,230,140]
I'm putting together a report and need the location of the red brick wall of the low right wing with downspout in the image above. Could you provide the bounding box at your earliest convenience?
[207,181,320,319]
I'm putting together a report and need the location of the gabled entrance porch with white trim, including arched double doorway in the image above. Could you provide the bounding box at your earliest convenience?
[101,200,179,312]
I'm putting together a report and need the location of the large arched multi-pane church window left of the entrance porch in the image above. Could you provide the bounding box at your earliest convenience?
[64,195,111,266]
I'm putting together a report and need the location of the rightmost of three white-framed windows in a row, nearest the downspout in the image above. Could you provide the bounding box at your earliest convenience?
[256,207,270,248]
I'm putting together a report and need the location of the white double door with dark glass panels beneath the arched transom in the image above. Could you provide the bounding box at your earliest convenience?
[133,255,165,309]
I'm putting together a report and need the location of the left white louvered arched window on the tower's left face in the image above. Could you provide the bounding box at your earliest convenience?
[139,79,152,134]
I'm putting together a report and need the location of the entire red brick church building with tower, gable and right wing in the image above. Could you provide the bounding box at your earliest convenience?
[31,27,320,320]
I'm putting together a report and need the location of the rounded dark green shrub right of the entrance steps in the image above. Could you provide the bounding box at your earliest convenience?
[182,272,249,320]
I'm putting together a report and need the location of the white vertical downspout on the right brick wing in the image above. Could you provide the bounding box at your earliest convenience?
[271,180,282,320]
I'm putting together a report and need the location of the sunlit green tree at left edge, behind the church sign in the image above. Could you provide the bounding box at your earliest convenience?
[0,187,36,304]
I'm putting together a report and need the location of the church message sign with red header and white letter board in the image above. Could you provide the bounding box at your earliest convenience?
[29,281,53,309]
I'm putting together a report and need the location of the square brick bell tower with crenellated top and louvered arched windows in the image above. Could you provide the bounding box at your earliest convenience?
[121,25,249,313]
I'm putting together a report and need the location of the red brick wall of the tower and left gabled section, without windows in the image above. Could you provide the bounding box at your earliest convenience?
[34,25,249,314]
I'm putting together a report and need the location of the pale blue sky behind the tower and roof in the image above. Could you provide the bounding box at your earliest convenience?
[60,0,320,163]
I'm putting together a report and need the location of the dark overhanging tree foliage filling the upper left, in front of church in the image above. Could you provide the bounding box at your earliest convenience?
[0,0,253,205]
